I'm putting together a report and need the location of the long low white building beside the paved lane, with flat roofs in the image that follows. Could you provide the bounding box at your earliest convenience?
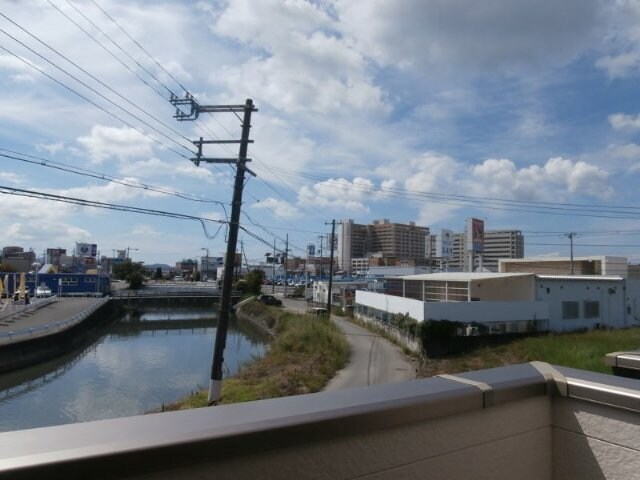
[355,273,640,333]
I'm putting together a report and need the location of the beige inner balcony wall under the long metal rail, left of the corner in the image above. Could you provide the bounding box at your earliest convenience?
[142,398,551,480]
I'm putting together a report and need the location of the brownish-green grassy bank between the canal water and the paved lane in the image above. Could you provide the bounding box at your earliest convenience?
[164,302,349,410]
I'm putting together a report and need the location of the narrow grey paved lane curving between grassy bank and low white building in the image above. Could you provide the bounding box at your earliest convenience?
[284,299,416,390]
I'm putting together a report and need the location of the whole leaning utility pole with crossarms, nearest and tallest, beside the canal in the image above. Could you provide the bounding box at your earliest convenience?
[171,93,257,405]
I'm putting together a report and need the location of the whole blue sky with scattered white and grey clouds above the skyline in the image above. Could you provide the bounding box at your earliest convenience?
[0,0,640,263]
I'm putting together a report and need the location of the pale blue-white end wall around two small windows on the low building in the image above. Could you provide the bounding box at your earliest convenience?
[536,277,627,332]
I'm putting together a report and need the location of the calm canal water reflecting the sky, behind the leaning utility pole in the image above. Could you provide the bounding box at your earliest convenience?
[0,308,266,431]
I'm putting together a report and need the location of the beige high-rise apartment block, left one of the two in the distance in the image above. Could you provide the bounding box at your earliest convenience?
[337,219,429,274]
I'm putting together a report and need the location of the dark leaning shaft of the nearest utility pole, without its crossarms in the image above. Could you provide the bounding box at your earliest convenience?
[208,99,253,405]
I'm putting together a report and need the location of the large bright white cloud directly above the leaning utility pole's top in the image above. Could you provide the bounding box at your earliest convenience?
[206,0,387,113]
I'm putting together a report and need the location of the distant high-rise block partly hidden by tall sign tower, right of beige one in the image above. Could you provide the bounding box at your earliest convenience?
[426,230,524,272]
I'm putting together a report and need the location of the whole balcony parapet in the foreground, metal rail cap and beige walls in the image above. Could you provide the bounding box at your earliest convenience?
[0,362,640,480]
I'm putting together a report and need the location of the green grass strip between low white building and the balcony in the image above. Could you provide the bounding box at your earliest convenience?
[420,328,640,377]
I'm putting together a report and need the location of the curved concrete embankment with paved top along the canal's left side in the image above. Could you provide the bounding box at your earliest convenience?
[0,298,119,373]
